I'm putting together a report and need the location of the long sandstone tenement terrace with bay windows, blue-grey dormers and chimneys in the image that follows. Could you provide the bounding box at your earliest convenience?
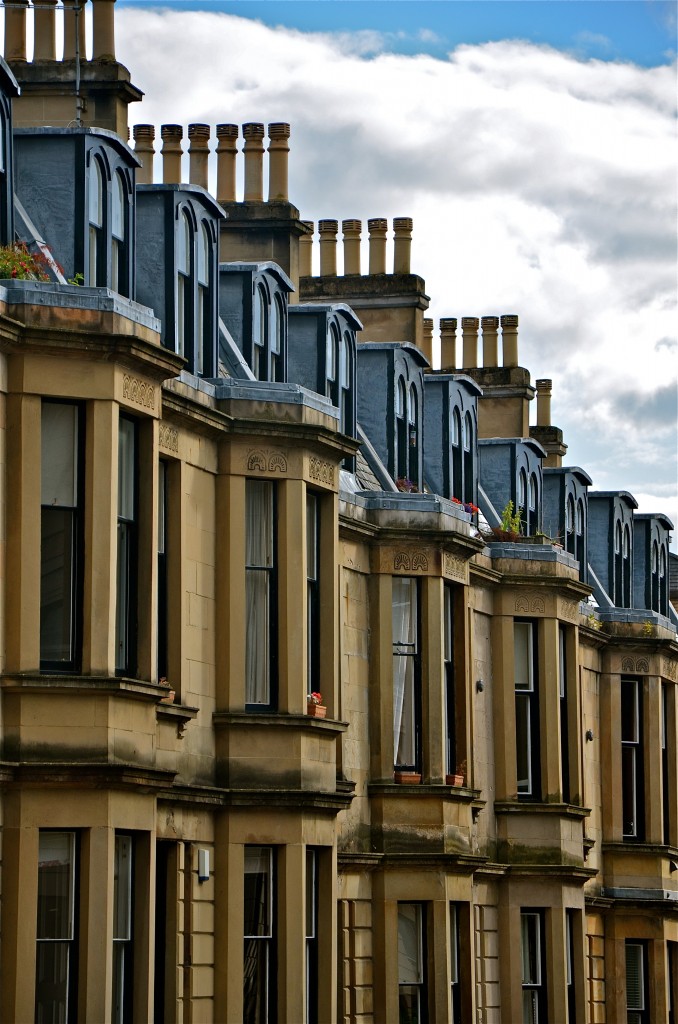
[0,0,678,1024]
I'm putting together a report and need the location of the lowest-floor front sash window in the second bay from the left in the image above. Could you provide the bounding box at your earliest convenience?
[243,846,276,1024]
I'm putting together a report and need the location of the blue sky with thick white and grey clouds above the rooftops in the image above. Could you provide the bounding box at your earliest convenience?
[116,0,678,545]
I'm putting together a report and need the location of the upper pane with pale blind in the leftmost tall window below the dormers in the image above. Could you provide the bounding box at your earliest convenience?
[40,401,78,508]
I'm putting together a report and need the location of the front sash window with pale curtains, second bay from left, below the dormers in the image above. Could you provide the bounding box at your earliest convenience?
[245,480,278,710]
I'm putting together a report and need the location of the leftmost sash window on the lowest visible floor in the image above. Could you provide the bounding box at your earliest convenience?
[35,830,78,1022]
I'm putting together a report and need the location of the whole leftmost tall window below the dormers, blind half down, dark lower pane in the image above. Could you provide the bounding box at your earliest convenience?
[40,401,83,671]
